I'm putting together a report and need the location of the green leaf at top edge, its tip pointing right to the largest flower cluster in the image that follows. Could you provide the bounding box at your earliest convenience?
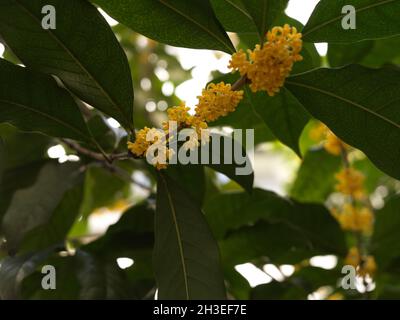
[93,0,234,53]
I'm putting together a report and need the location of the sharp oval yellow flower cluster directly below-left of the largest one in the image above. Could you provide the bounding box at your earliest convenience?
[195,82,243,122]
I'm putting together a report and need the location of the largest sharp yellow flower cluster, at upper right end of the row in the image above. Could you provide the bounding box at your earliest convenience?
[229,24,303,96]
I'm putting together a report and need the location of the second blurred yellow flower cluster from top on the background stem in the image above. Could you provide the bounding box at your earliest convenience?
[335,168,365,200]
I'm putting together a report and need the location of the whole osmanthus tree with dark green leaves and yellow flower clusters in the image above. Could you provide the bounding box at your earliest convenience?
[0,0,400,299]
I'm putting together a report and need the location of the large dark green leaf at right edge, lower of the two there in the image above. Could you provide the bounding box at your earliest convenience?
[286,65,400,178]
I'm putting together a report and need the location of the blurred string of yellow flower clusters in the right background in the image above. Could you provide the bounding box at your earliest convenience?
[310,123,377,277]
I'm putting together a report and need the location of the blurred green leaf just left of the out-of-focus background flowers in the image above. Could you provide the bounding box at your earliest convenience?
[290,149,342,203]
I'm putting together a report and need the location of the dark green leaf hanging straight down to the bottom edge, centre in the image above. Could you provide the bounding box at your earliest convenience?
[154,174,225,299]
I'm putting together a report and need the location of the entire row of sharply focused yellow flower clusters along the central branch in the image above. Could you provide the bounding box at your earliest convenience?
[128,24,302,170]
